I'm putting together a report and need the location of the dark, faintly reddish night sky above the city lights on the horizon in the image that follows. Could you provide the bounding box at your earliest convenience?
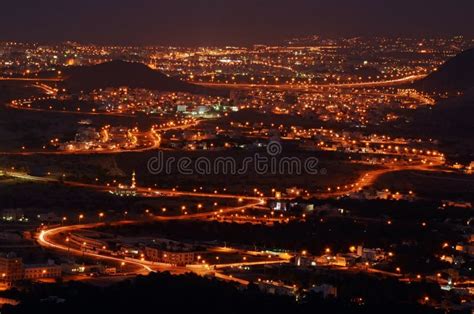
[0,0,474,45]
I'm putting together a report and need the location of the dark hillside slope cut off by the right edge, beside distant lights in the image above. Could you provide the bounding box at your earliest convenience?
[415,48,474,94]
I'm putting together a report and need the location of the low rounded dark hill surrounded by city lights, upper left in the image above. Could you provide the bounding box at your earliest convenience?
[63,60,228,96]
